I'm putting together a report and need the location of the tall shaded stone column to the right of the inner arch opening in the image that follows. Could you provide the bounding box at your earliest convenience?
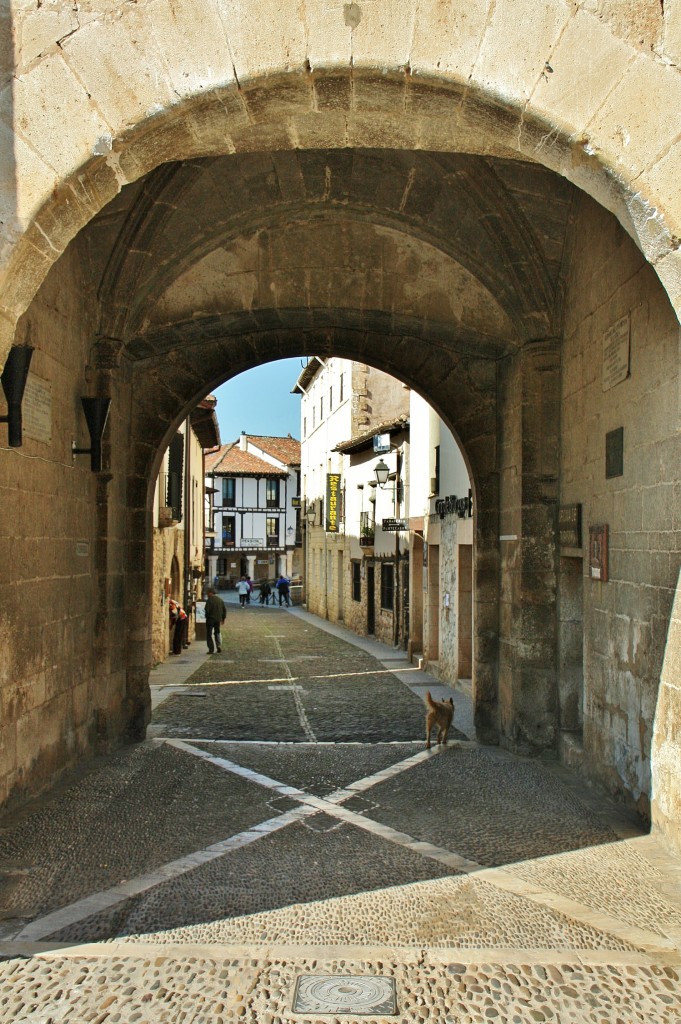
[499,339,560,754]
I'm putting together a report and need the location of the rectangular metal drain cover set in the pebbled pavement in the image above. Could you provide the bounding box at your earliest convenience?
[293,974,397,1014]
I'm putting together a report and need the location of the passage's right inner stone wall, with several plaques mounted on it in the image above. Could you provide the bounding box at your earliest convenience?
[560,192,681,814]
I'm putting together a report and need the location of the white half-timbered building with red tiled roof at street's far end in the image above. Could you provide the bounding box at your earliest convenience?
[205,433,301,589]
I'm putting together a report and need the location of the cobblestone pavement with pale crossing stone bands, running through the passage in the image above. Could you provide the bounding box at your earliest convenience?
[0,606,681,1024]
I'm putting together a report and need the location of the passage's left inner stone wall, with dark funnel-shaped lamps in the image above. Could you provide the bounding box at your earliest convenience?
[0,239,127,803]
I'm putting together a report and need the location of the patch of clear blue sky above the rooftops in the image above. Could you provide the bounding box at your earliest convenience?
[213,356,305,444]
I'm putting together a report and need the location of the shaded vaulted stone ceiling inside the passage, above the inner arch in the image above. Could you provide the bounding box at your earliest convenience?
[84,150,574,358]
